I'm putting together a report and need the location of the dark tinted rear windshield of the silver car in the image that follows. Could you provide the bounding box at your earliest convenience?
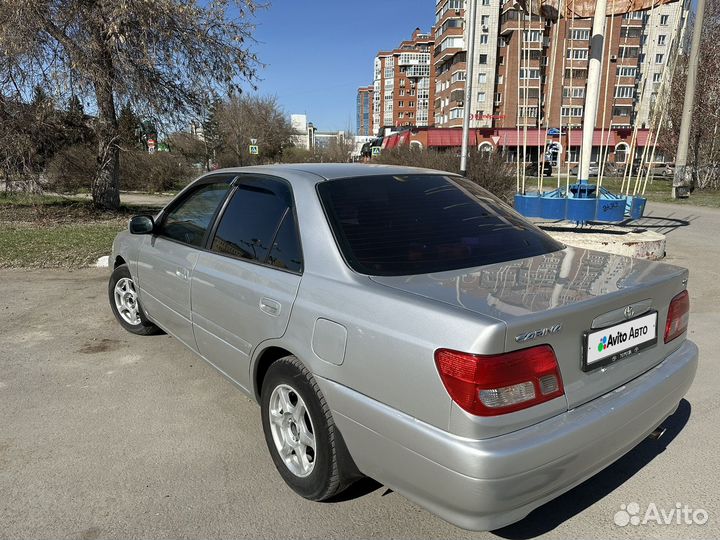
[318,174,563,276]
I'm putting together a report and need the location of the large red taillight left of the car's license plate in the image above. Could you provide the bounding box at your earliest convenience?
[435,345,565,416]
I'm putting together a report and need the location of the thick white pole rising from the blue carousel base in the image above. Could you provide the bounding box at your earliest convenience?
[570,0,607,182]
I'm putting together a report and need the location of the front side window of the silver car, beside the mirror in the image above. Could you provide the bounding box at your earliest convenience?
[159,182,230,247]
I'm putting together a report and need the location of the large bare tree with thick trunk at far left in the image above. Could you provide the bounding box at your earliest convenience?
[0,0,257,209]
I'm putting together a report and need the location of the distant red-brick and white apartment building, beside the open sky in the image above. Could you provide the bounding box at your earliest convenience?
[371,28,435,132]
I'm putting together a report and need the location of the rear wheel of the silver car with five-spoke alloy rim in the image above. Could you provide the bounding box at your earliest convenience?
[260,356,362,501]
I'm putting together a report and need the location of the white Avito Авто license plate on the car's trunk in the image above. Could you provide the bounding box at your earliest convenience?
[583,311,657,371]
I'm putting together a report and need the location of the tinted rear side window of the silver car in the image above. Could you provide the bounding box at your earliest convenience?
[211,179,302,272]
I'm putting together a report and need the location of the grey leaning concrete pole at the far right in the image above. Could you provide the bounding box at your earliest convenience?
[672,0,705,199]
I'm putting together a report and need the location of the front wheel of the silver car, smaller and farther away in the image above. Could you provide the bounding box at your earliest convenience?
[108,264,162,336]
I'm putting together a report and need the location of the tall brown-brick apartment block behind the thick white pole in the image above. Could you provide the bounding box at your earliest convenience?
[498,2,683,133]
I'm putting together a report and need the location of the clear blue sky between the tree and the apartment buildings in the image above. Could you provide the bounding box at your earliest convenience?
[253,0,435,131]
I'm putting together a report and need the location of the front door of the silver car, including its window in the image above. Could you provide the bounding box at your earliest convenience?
[138,175,235,349]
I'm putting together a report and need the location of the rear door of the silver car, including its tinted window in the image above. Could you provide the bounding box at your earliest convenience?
[191,175,302,390]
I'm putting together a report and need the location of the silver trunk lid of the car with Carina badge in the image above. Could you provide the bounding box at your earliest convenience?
[372,247,687,408]
